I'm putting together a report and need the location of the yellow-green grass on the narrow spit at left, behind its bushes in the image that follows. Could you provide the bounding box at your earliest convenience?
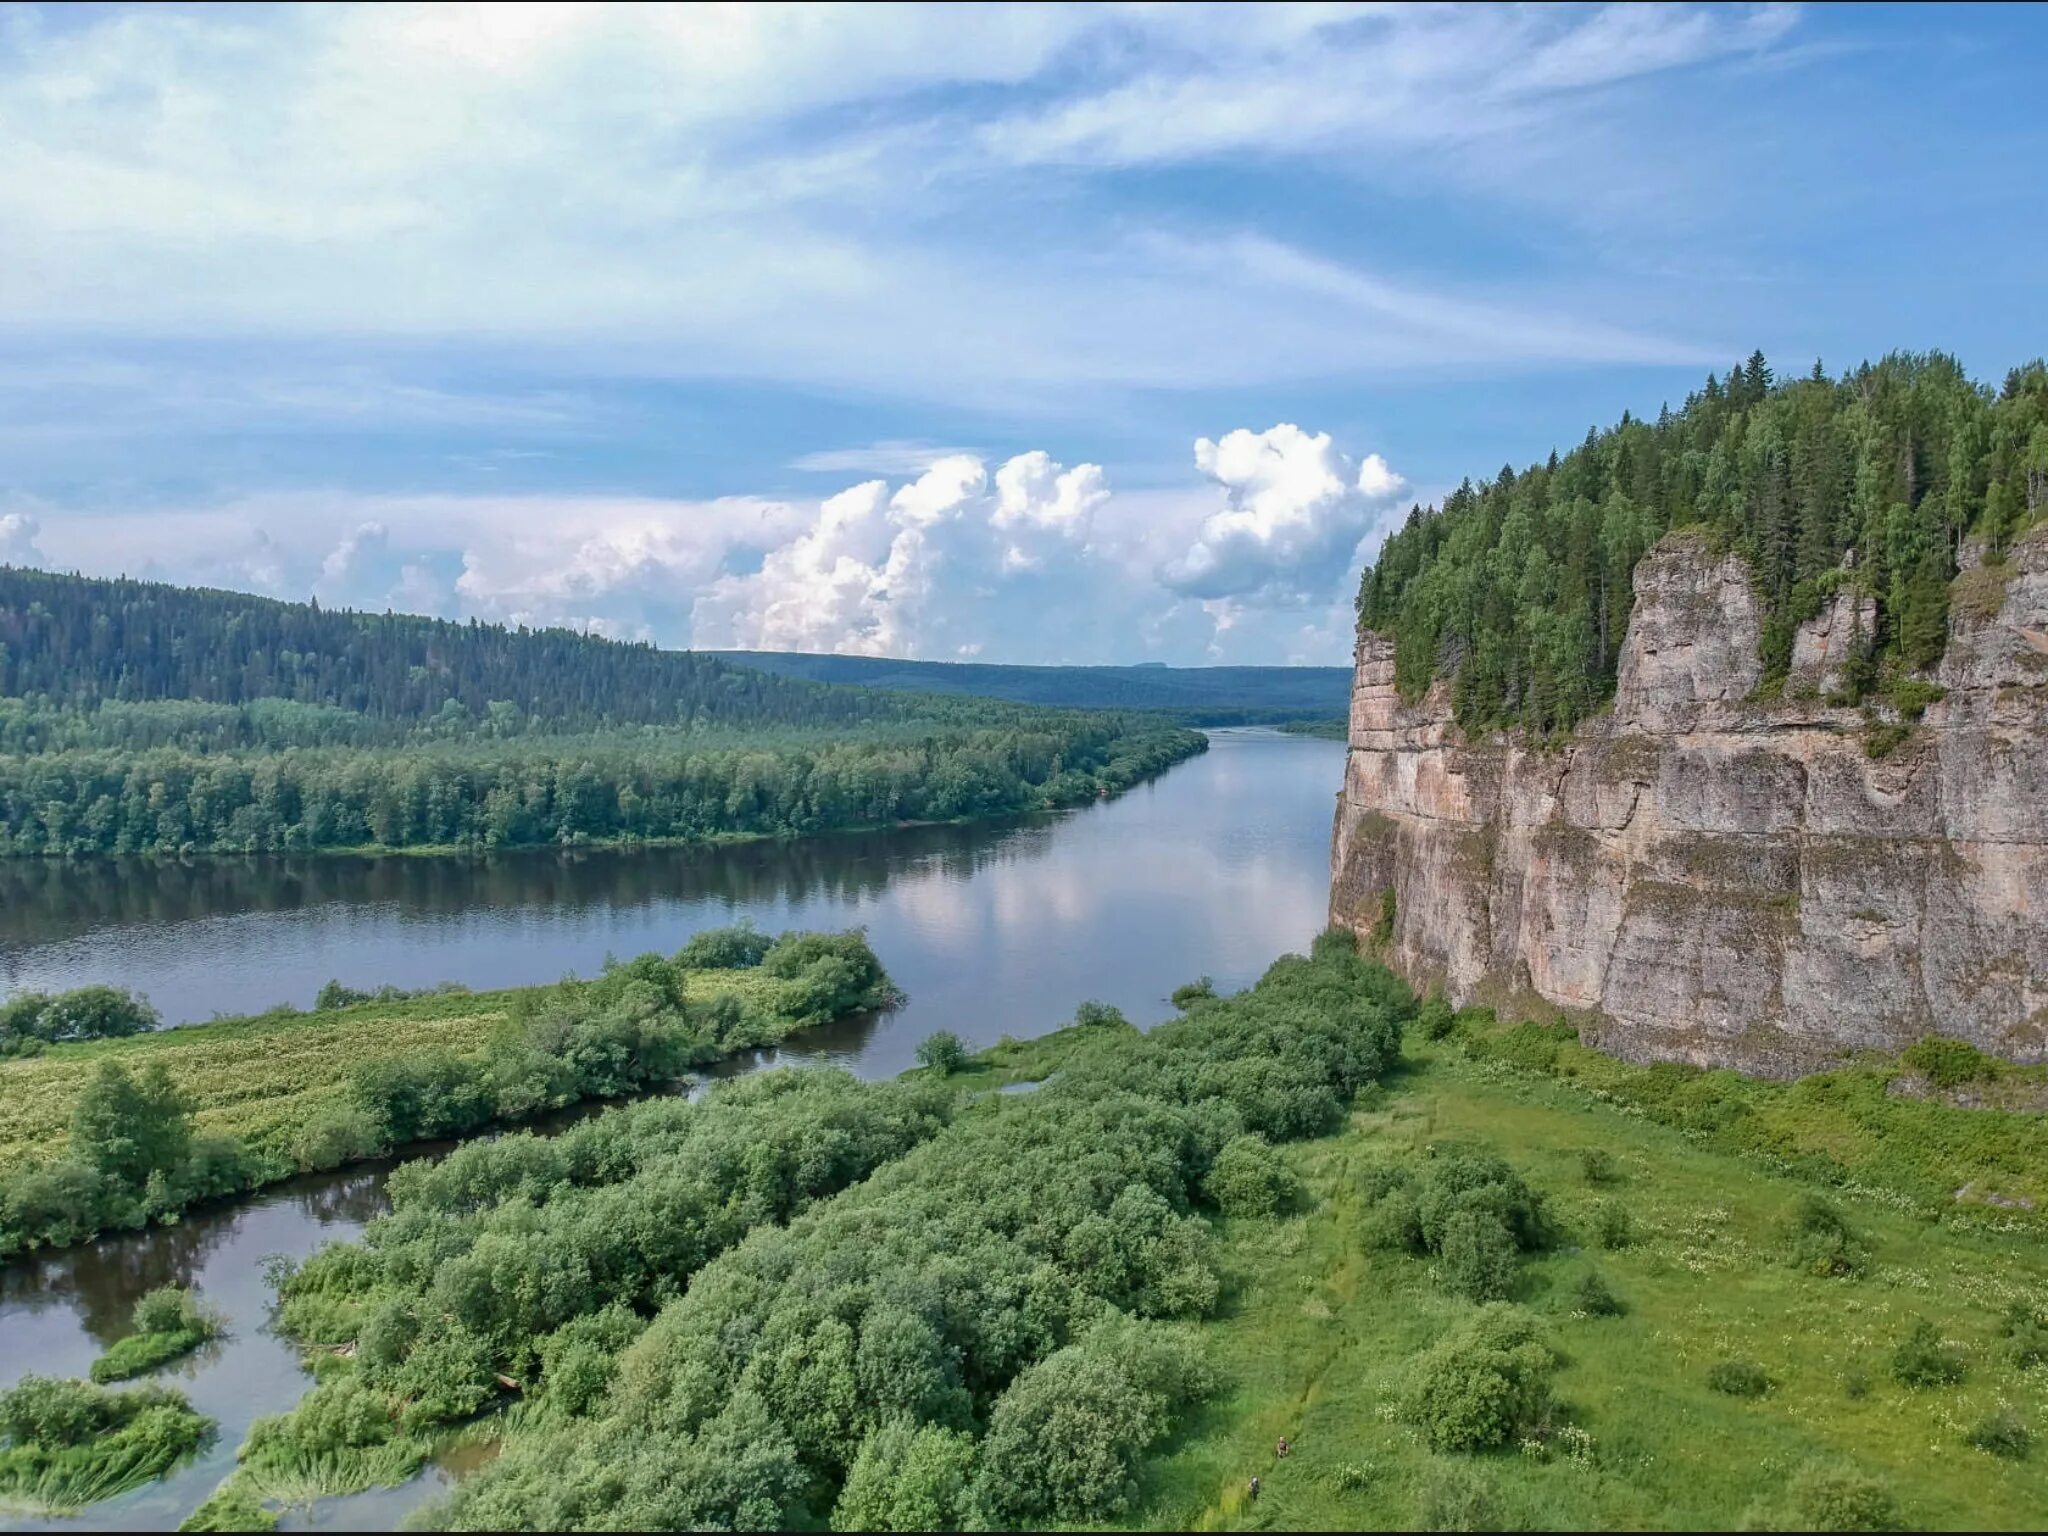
[0,971,782,1180]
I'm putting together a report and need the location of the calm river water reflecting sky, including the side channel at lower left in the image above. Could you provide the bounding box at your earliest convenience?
[0,731,1343,1530]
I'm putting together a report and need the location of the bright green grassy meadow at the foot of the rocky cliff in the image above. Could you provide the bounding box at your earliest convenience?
[1122,1034,2048,1530]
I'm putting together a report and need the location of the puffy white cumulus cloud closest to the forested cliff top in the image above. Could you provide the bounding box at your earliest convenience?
[1159,422,1407,627]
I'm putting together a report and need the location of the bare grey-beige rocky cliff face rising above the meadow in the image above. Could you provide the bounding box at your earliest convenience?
[1331,528,2048,1075]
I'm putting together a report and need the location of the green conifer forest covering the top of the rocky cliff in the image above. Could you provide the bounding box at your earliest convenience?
[1358,352,2048,731]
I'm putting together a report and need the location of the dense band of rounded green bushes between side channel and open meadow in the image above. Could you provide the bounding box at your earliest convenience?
[368,942,1413,1528]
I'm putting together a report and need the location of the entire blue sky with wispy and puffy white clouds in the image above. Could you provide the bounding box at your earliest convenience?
[0,4,2048,666]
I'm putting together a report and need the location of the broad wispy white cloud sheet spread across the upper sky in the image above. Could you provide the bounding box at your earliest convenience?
[0,6,1761,415]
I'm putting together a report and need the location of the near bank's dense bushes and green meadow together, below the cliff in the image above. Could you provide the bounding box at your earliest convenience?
[0,928,2048,1530]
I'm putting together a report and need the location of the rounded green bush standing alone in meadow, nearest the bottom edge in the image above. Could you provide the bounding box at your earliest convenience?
[1403,1303,1559,1450]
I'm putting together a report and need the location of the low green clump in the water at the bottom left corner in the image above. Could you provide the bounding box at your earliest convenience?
[0,1374,213,1513]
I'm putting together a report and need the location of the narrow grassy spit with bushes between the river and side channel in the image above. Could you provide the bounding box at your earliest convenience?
[0,926,897,1255]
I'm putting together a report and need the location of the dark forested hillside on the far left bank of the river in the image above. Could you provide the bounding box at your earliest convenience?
[0,569,1202,856]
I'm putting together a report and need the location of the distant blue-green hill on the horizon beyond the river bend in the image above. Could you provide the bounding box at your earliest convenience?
[702,651,1352,725]
